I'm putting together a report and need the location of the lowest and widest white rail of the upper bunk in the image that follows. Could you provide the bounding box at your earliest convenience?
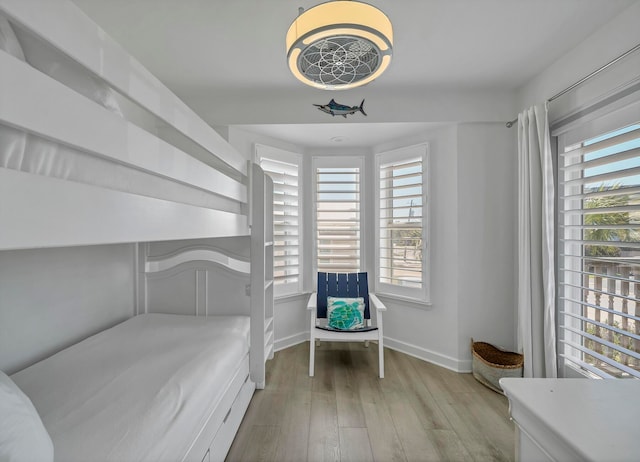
[0,169,246,250]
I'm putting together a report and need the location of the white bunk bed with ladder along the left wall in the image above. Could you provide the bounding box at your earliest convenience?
[0,0,273,461]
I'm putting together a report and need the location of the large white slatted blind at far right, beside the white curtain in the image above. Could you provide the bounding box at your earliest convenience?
[558,124,640,378]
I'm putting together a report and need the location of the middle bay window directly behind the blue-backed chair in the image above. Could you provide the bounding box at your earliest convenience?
[314,158,362,273]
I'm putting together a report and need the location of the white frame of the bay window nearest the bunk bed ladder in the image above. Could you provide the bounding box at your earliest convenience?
[254,143,305,299]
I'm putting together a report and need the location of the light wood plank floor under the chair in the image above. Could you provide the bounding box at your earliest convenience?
[227,342,514,462]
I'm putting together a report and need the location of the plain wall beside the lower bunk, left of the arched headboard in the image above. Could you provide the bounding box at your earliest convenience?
[0,244,135,374]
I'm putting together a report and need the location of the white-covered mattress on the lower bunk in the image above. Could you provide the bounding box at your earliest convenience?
[12,314,249,462]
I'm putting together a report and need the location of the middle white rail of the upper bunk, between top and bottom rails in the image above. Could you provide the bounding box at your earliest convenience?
[0,52,247,203]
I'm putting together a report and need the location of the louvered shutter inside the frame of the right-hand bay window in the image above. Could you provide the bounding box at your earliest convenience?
[379,157,423,288]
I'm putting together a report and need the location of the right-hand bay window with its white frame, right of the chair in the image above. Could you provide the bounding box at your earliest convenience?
[376,145,428,300]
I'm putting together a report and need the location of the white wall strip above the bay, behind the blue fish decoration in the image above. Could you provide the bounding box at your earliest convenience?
[185,86,515,126]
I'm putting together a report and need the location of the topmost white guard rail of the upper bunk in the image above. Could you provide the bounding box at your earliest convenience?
[0,0,247,176]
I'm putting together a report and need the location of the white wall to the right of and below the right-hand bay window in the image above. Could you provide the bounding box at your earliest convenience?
[376,125,460,370]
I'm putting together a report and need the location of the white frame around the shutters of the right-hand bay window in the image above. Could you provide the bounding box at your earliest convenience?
[374,143,431,304]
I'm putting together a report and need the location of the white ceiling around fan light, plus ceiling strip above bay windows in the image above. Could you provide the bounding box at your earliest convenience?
[74,0,637,147]
